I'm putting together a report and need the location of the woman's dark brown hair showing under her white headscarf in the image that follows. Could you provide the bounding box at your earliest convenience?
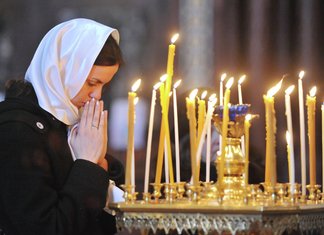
[94,35,124,66]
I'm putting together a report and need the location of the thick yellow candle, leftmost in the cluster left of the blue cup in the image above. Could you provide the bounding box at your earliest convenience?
[186,89,199,186]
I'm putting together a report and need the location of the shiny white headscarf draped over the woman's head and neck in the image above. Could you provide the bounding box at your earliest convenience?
[25,18,119,125]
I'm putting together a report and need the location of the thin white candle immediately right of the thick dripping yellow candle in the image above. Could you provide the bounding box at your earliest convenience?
[285,85,295,192]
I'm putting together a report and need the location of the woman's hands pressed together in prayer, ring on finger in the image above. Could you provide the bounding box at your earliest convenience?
[71,98,108,170]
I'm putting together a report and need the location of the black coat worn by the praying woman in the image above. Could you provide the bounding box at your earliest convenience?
[0,81,123,235]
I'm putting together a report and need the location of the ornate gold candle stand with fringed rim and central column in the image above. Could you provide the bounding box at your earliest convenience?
[108,105,324,235]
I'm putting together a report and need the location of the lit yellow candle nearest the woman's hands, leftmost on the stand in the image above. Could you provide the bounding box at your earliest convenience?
[125,79,141,185]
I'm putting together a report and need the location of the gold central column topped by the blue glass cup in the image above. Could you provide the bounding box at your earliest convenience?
[213,104,258,203]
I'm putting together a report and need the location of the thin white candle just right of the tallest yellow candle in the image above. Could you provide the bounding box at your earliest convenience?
[173,79,181,183]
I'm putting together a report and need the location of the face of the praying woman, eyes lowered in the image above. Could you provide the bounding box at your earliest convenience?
[71,64,119,108]
